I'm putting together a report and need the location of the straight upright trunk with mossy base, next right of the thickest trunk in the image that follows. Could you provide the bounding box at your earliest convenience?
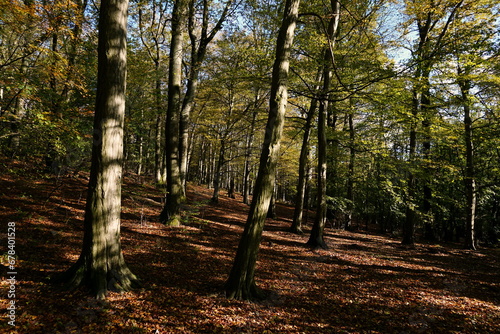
[160,0,187,226]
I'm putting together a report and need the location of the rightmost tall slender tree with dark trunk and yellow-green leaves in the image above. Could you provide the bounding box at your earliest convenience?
[451,1,498,250]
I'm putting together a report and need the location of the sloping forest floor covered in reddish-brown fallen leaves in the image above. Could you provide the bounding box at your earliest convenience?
[0,160,500,333]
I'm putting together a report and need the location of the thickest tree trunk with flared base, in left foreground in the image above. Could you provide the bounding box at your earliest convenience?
[58,0,138,299]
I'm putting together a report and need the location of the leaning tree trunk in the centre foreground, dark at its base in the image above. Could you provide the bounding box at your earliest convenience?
[226,0,300,299]
